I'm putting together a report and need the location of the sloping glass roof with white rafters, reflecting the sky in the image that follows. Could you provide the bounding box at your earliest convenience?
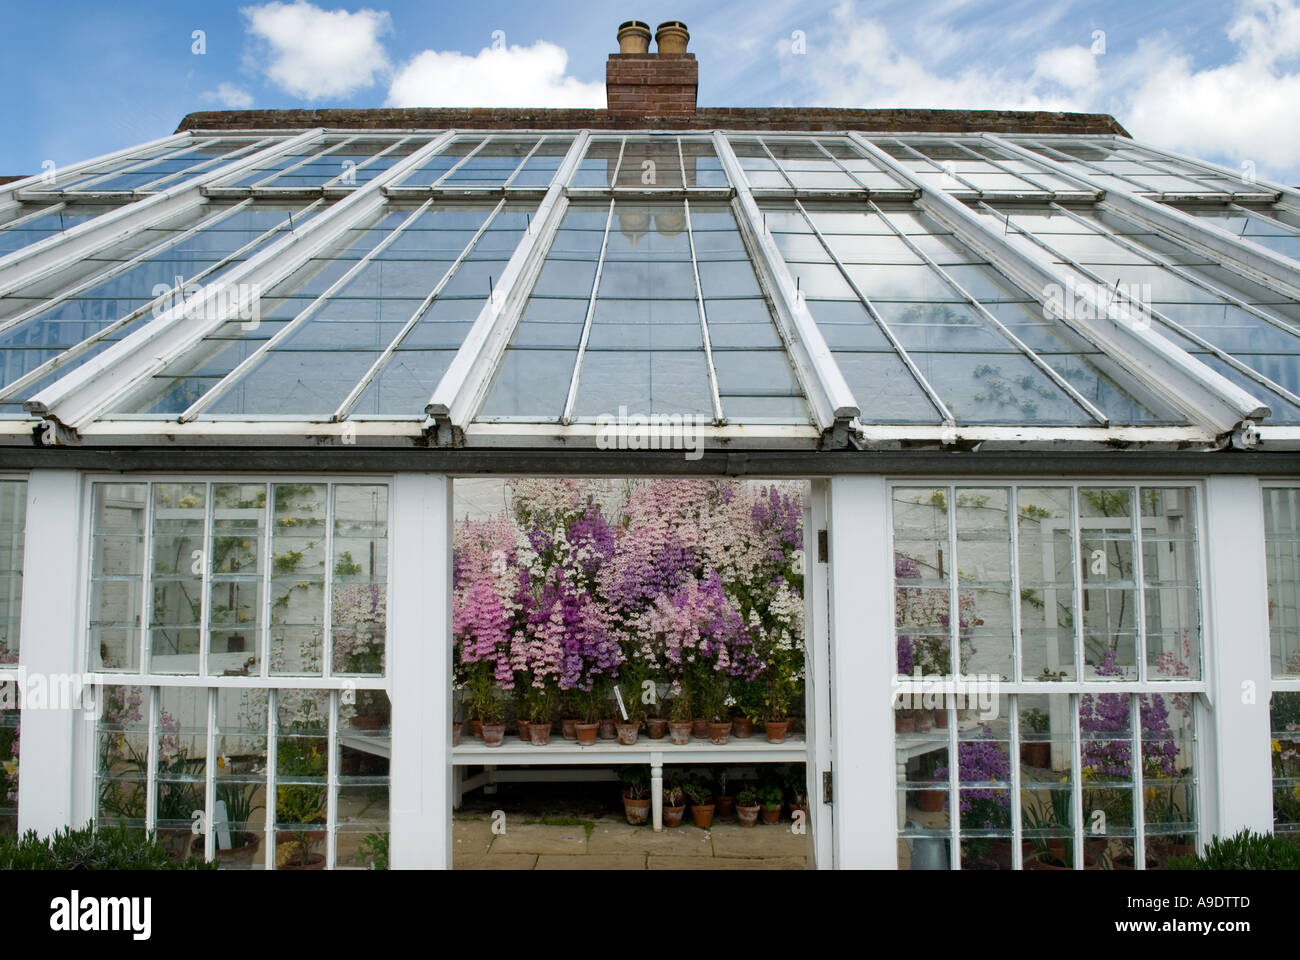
[0,130,1300,437]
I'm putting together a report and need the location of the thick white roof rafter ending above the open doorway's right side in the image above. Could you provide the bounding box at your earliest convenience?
[714,133,861,431]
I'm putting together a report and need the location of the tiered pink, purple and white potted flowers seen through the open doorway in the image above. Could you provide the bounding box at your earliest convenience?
[452,479,803,722]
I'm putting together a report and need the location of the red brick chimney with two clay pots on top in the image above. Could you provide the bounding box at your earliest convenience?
[605,20,699,120]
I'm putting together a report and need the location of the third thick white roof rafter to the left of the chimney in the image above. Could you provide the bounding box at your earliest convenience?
[0,130,319,297]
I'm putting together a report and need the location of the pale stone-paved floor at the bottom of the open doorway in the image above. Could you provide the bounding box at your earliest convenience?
[452,813,810,870]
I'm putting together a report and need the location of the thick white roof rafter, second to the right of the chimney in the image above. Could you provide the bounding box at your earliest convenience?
[849,133,1268,433]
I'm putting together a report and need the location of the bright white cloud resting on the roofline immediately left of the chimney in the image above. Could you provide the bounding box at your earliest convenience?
[387,40,605,107]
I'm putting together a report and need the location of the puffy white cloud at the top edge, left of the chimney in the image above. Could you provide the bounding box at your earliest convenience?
[241,0,393,100]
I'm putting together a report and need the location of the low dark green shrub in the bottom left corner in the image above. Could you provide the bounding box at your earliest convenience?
[0,823,217,870]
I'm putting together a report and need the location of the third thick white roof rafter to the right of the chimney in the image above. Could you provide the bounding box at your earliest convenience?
[983,134,1300,298]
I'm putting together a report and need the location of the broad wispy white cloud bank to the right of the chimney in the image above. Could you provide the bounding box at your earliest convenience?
[776,0,1300,180]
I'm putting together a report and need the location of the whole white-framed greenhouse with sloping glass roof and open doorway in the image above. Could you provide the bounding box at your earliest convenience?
[0,16,1300,869]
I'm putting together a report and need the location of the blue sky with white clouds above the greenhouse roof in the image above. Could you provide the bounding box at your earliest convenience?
[0,0,1300,182]
